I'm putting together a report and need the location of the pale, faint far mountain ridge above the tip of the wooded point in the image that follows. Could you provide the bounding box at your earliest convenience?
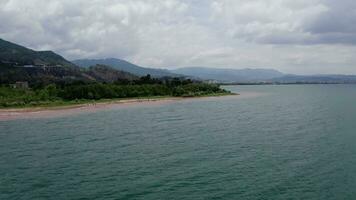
[171,67,284,82]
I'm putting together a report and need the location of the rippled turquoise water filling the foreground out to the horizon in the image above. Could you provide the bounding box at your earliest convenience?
[0,85,356,200]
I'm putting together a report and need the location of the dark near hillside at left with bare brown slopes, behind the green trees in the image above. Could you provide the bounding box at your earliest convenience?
[0,39,139,85]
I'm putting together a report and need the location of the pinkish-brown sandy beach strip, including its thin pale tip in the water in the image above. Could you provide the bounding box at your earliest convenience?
[0,93,261,121]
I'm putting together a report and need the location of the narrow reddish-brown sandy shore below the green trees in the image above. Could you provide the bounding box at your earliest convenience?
[0,93,239,121]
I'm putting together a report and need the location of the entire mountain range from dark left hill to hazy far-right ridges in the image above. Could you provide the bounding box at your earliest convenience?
[0,39,356,84]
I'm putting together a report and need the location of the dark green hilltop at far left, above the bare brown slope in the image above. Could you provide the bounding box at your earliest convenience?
[0,39,75,67]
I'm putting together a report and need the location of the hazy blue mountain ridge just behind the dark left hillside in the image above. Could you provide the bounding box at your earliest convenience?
[72,58,179,77]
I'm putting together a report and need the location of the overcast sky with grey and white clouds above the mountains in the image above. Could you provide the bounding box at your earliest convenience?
[0,0,356,74]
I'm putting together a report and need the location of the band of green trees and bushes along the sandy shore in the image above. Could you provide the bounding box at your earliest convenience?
[0,75,230,108]
